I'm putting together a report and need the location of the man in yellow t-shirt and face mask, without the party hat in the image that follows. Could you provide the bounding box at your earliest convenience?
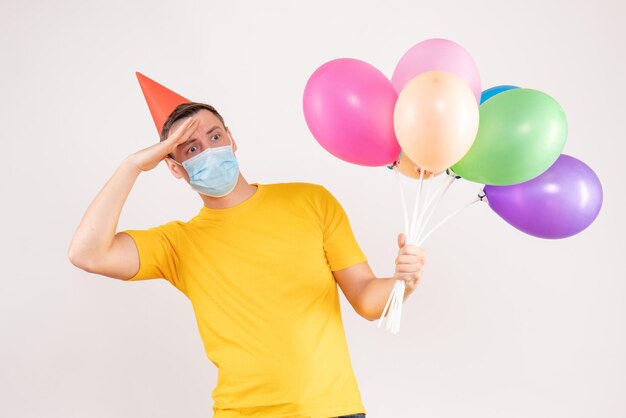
[69,99,425,418]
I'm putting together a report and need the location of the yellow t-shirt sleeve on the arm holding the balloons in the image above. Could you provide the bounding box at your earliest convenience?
[319,186,367,271]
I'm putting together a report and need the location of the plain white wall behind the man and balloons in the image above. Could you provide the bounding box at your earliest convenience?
[0,0,626,418]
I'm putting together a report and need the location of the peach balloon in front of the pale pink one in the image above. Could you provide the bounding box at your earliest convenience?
[393,71,479,174]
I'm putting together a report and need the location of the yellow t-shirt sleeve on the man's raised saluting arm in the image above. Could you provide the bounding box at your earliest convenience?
[121,221,181,288]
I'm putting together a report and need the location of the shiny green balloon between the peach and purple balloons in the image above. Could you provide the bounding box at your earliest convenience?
[451,88,567,186]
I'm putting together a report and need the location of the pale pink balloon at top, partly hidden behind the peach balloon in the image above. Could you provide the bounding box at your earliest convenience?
[391,39,481,103]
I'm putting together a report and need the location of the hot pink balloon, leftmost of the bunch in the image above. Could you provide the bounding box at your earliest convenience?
[303,58,400,167]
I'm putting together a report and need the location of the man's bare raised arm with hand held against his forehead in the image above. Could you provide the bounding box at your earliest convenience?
[68,118,197,280]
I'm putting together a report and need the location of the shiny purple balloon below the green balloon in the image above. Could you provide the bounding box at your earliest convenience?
[484,154,602,239]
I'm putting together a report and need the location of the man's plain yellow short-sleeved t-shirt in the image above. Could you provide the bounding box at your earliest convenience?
[123,183,367,418]
